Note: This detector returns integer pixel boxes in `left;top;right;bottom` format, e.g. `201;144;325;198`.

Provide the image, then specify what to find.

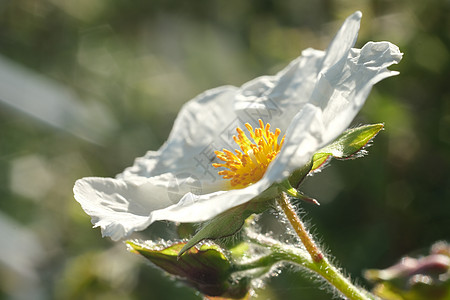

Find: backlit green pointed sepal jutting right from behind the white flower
311;124;384;171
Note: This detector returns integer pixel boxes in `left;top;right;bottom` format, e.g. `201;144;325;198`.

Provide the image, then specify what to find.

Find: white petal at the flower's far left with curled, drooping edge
73;169;230;240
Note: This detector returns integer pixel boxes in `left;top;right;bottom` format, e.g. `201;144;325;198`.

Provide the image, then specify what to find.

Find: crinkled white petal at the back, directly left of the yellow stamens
119;86;238;181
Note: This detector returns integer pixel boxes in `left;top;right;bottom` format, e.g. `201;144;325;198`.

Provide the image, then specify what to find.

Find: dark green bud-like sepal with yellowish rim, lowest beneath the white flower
127;241;249;299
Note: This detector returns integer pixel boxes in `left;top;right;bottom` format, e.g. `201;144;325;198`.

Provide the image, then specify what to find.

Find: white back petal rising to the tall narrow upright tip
235;12;361;132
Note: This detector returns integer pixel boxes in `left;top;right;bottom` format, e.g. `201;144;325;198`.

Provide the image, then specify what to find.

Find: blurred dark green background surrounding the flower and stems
0;0;450;299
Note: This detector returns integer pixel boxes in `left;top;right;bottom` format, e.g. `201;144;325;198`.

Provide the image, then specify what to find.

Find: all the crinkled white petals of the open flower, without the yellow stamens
74;12;402;240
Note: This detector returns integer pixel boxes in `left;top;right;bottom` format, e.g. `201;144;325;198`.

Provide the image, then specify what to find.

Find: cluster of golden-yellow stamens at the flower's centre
212;120;285;189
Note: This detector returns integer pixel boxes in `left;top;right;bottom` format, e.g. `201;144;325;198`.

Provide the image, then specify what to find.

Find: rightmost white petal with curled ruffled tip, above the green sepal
310;42;402;142
